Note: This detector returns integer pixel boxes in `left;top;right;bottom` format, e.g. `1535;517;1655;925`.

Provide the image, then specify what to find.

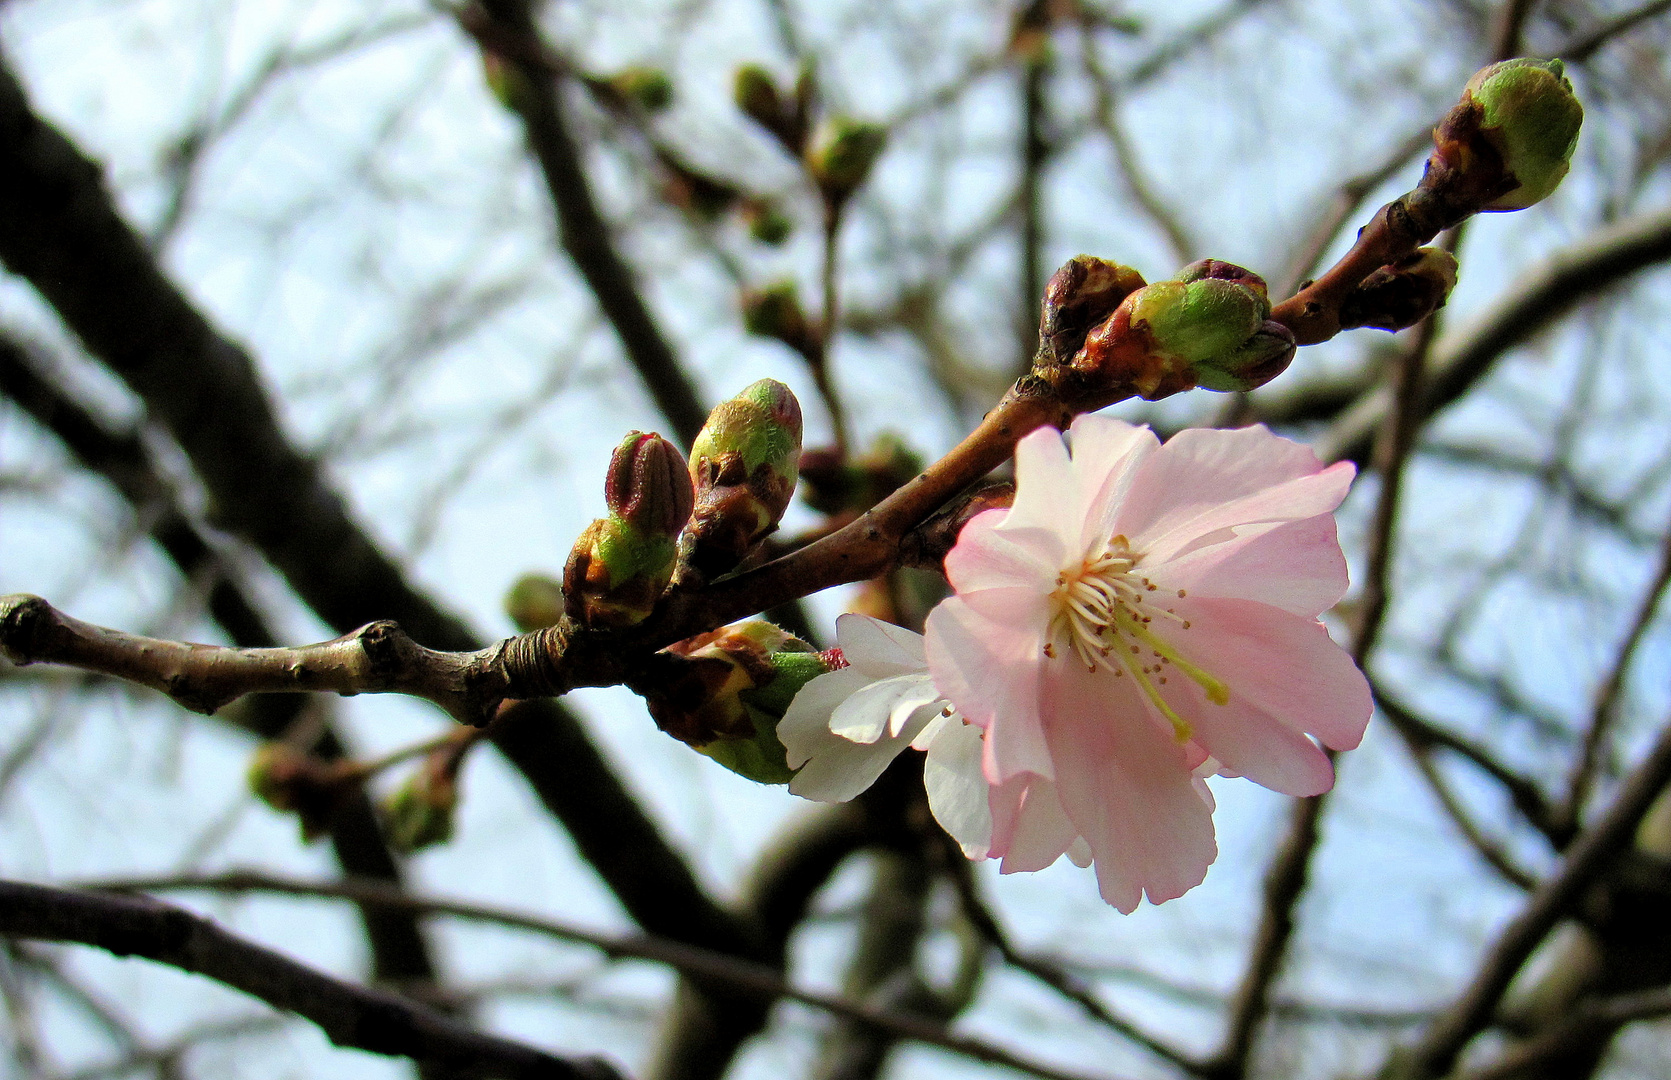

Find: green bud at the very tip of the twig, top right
1462;57;1584;211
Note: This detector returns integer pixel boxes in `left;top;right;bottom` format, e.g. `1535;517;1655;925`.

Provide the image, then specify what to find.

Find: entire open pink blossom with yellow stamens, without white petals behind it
926;416;1372;911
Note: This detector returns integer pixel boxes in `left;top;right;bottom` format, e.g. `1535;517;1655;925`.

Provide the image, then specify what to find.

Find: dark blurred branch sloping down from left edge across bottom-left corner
0;881;620;1080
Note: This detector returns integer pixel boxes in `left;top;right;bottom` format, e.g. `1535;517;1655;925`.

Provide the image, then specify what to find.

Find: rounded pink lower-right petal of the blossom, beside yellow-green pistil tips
1151;595;1374;752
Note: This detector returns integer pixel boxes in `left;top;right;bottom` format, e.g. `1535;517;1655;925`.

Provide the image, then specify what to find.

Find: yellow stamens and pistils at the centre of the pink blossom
1044;537;1230;742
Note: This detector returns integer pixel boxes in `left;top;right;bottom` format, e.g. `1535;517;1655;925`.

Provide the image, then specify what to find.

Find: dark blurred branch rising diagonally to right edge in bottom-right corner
1397;722;1671;1080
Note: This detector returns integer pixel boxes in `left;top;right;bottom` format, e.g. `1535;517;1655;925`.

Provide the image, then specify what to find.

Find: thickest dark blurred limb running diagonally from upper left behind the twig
0;55;749;950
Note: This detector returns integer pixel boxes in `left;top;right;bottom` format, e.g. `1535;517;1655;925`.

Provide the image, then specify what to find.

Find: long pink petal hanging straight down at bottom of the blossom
1044;664;1218;913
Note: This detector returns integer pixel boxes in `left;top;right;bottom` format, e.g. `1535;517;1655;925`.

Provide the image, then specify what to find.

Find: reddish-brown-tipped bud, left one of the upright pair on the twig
563;431;695;629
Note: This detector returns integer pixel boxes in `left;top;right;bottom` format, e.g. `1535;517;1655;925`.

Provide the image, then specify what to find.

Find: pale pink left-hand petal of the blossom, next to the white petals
924;597;1051;782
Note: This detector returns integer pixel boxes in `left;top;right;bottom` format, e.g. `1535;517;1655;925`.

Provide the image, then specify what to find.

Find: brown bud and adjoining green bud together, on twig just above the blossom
1034;256;1295;401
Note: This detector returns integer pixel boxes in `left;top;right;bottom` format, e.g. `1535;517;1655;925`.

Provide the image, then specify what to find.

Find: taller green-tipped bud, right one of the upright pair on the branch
680;380;800;577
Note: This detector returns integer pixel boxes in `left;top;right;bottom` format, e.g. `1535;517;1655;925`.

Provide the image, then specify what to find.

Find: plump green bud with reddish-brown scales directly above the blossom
1073;259;1295;401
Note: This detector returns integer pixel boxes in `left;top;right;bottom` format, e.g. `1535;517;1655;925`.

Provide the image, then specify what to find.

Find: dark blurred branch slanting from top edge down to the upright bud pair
458;0;709;446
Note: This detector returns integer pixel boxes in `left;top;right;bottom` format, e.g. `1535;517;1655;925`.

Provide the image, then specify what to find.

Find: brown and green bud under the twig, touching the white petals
648;620;836;784
